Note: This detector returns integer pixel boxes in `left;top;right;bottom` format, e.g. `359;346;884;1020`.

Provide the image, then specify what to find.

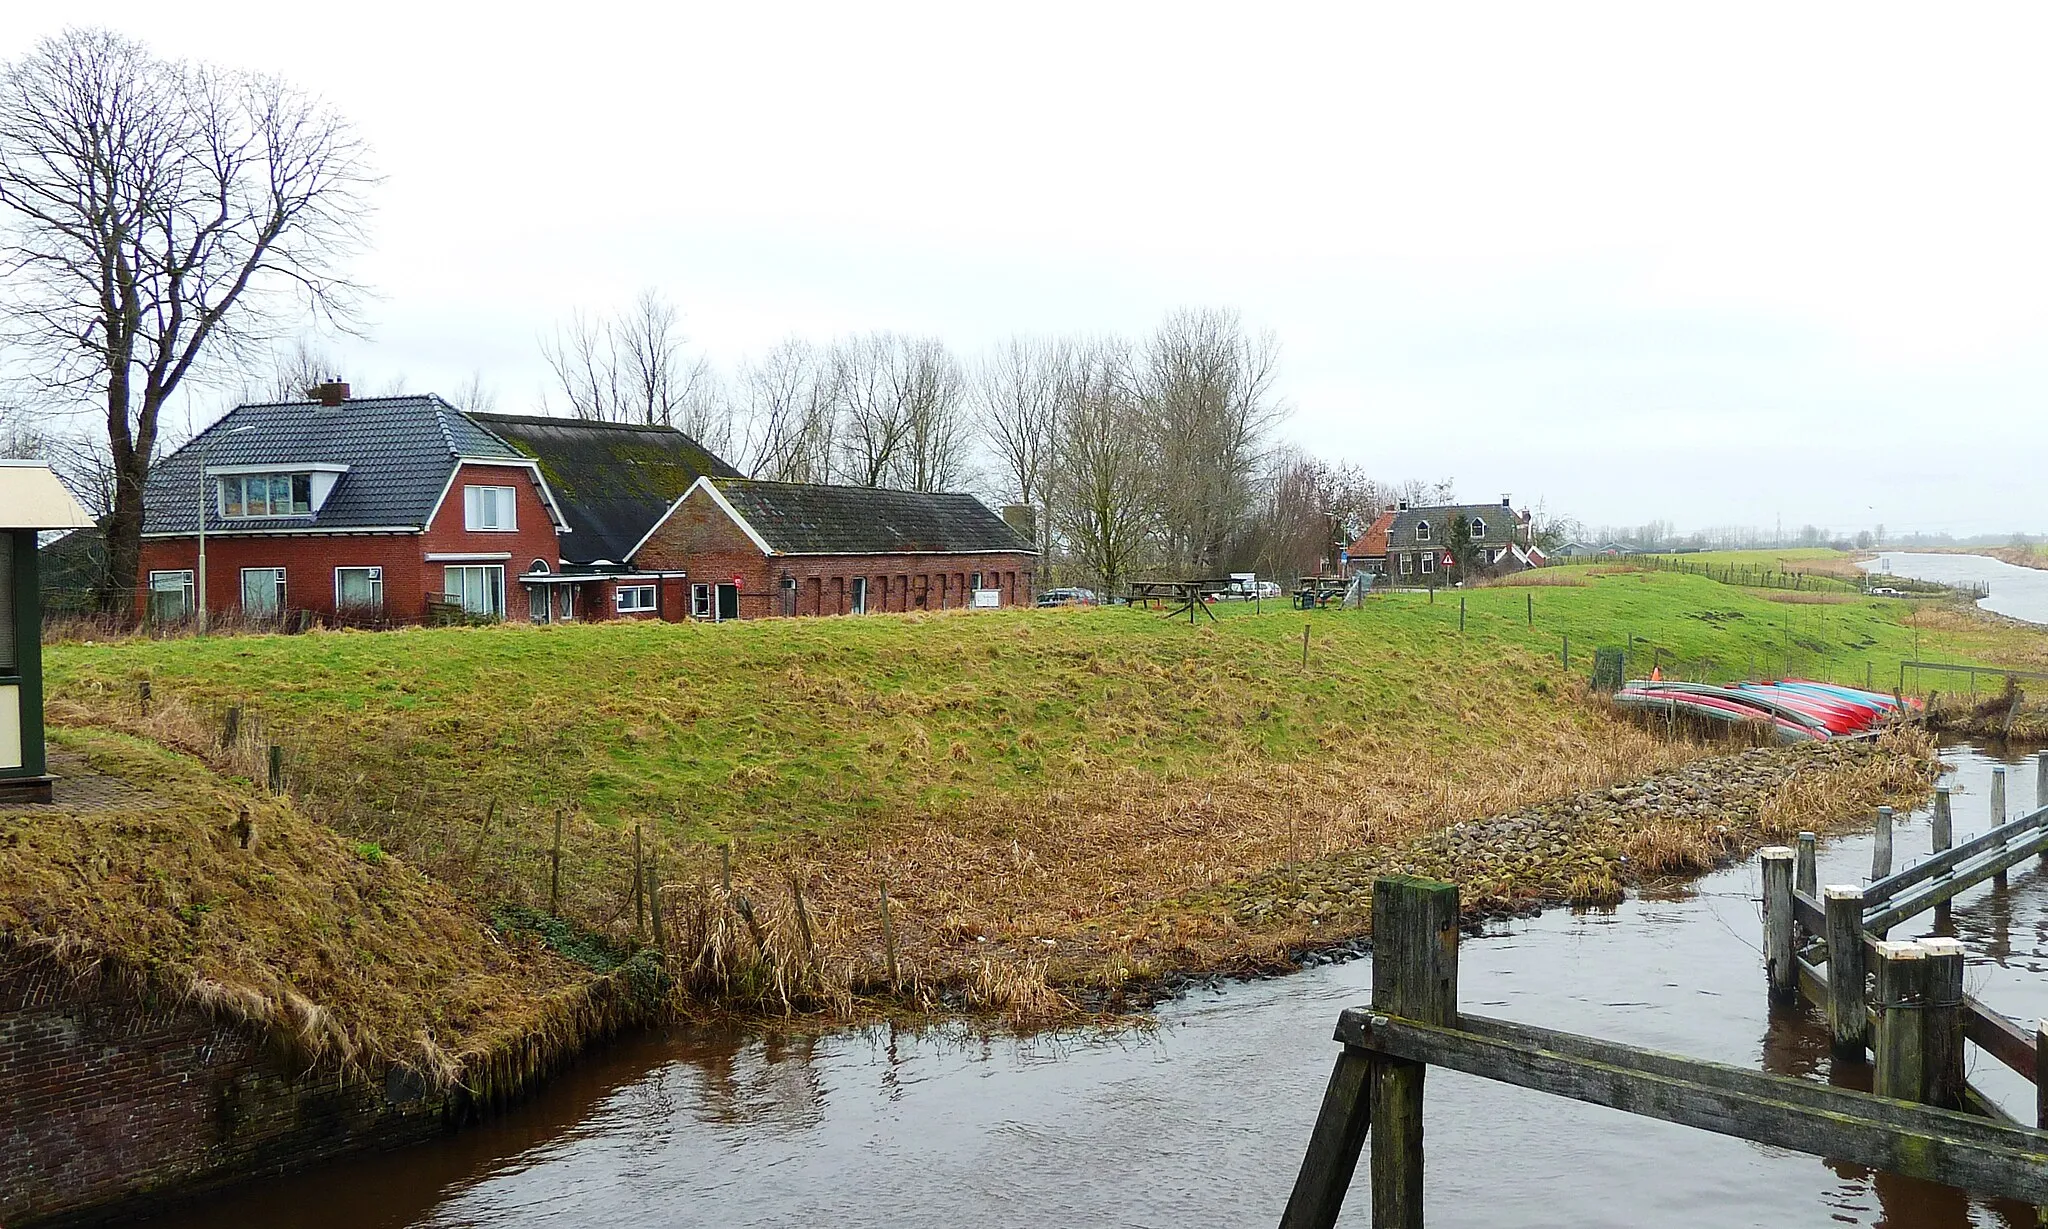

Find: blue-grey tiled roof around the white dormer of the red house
143;395;526;533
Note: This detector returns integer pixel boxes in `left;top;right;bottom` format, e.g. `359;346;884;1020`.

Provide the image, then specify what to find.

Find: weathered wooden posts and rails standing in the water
1280;848;2048;1229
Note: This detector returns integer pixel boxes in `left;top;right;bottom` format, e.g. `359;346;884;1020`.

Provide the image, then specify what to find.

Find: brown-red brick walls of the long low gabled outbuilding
633;492;1038;619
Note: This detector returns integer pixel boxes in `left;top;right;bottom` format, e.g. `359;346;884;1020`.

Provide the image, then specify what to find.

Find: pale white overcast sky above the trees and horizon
0;0;2048;533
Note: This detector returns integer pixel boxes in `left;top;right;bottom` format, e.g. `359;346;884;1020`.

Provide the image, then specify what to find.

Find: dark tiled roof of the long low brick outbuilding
713;477;1032;555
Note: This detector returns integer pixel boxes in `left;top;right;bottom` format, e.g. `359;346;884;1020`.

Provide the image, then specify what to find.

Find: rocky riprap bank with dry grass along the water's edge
1229;735;1939;938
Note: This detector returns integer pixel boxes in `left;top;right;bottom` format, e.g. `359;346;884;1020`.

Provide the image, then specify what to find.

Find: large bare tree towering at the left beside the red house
0;29;373;606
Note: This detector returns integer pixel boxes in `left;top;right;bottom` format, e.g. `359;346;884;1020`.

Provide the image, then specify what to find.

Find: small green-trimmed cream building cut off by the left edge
0;461;92;803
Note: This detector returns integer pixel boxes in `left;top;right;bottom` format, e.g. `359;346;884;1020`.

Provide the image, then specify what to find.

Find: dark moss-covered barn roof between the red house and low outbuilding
469;414;739;563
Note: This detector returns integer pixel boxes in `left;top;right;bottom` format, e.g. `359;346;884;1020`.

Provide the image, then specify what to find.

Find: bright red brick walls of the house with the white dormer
135;463;561;623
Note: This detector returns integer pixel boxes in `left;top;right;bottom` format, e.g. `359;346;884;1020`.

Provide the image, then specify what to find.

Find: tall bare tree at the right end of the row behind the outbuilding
1137;309;1284;571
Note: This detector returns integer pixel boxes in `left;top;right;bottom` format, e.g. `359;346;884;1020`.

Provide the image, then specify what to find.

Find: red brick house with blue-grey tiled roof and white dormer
137;383;567;623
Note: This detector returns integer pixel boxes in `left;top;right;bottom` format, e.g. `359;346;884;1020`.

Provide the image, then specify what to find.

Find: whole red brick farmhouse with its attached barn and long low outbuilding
137;383;1038;623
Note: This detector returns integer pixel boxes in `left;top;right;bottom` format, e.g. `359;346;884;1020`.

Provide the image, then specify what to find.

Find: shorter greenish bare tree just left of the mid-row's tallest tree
1049;340;1159;592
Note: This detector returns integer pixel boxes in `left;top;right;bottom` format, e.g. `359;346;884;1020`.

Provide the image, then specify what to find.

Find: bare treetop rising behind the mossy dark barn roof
541;291;729;436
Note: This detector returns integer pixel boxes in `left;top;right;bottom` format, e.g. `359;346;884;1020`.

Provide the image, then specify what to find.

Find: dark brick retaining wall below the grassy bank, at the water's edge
0;958;442;1229
